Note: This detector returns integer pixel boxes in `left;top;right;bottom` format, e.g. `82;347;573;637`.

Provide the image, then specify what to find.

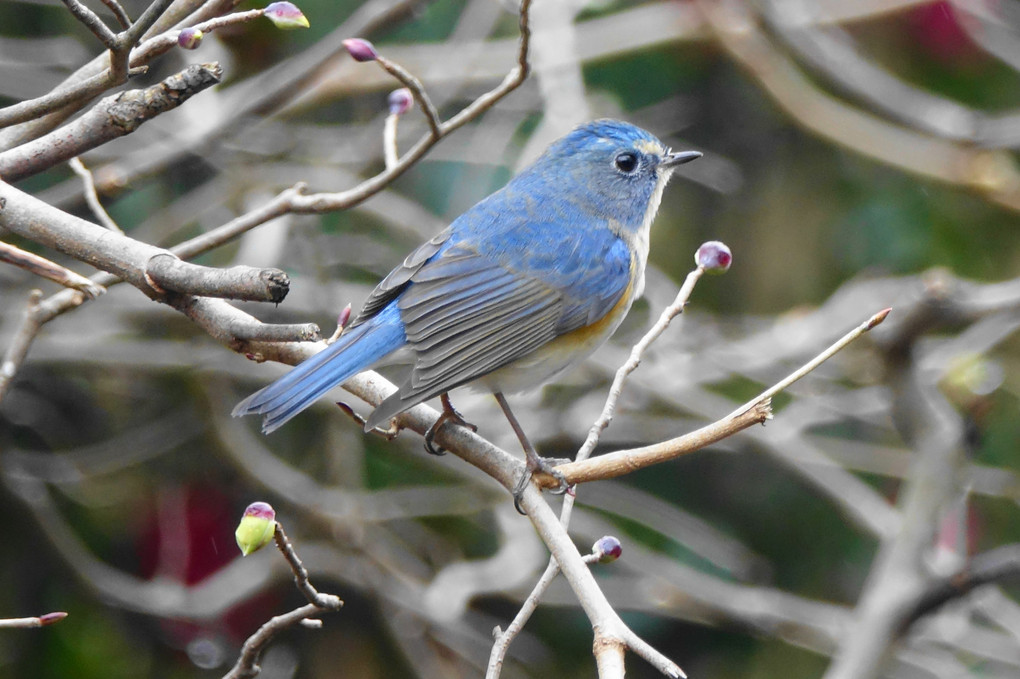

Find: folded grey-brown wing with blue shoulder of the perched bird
369;205;631;424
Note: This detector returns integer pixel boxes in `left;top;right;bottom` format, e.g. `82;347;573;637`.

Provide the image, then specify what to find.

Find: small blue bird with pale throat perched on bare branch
234;119;702;489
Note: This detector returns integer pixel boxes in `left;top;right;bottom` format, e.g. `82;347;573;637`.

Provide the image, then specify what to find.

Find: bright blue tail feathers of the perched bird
231;308;407;433
